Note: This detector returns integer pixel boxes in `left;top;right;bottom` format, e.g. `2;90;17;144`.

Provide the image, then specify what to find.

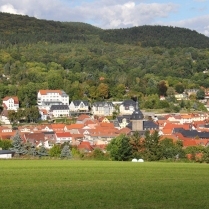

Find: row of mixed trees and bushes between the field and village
0;131;209;163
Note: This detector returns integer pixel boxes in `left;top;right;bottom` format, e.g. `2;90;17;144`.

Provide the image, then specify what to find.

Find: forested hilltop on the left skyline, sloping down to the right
0;12;101;44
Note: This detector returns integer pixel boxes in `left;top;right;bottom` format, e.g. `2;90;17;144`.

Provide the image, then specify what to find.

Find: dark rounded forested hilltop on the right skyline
101;26;209;48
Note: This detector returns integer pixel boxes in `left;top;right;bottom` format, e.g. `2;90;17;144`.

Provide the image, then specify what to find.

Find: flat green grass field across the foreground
0;160;209;209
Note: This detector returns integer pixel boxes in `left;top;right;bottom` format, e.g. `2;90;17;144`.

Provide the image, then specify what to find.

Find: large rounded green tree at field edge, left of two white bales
107;135;132;161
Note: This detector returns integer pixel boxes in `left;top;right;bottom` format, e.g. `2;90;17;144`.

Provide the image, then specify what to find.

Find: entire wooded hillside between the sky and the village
0;13;209;111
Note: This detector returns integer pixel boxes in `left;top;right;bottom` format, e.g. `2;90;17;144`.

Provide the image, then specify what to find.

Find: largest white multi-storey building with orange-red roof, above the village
37;90;69;110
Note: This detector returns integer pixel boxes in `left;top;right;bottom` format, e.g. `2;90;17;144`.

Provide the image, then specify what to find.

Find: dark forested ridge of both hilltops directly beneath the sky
0;13;209;48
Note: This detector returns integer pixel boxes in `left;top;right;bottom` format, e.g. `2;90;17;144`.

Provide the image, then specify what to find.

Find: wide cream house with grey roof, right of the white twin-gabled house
92;102;115;116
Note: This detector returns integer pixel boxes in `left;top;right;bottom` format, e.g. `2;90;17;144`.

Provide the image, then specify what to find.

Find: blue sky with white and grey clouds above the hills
0;0;209;36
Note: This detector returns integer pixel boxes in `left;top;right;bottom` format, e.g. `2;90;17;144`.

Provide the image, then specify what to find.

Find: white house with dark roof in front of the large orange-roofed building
49;105;70;118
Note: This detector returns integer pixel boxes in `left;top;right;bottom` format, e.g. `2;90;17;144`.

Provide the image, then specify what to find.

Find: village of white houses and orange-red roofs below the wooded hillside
0;90;209;152
